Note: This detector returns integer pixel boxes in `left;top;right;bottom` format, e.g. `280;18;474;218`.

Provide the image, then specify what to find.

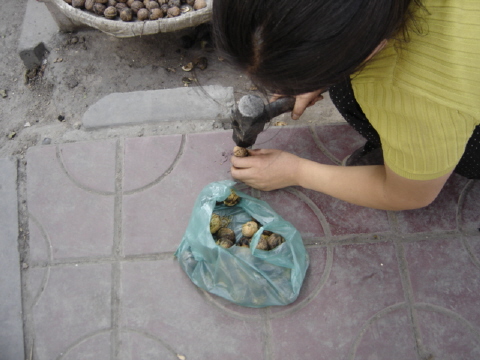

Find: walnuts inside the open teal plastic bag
210;190;285;250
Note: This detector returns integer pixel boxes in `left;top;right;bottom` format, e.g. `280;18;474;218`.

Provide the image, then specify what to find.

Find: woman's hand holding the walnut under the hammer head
231;149;302;191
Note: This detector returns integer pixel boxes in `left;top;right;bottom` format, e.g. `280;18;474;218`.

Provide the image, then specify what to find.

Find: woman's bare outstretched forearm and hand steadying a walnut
232;149;450;210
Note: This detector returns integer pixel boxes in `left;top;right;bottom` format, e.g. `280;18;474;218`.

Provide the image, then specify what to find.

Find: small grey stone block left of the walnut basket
18;0;58;69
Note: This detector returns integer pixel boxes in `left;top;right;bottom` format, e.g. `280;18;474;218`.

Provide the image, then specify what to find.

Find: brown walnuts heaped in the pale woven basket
64;0;207;21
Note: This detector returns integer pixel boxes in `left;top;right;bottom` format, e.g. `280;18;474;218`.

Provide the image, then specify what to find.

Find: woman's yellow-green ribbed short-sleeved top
352;0;480;180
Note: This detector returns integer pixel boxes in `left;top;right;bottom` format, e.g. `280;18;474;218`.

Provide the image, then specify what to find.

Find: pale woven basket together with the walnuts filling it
44;0;212;37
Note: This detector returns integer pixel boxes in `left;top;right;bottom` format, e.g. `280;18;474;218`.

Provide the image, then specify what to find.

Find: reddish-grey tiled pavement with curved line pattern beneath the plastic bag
23;124;480;360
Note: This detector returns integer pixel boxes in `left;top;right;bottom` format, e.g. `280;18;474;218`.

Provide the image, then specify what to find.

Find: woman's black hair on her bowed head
212;0;421;95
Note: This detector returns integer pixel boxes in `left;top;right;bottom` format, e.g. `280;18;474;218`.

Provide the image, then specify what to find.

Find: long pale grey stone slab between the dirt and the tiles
82;85;235;130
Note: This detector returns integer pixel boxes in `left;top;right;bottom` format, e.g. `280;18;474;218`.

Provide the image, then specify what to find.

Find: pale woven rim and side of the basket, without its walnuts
43;0;212;37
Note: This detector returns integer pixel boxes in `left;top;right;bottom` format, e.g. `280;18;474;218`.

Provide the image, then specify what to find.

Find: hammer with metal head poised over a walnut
232;95;295;148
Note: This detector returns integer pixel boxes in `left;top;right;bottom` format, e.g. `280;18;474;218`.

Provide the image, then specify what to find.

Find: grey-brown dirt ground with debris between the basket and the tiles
0;0;264;158
